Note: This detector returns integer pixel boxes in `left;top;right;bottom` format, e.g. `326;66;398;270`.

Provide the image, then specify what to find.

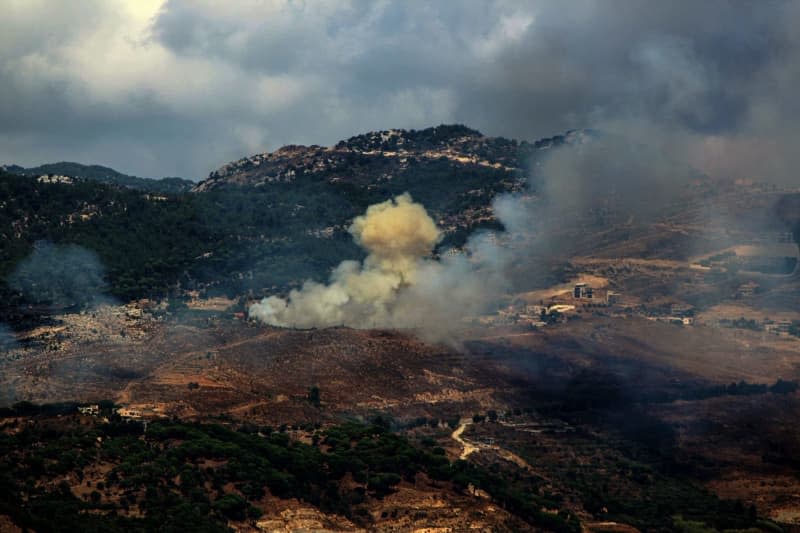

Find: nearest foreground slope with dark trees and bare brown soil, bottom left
0;414;556;533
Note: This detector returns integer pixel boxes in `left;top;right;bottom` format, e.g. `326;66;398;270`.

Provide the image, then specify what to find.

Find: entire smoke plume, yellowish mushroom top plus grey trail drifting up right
250;119;800;345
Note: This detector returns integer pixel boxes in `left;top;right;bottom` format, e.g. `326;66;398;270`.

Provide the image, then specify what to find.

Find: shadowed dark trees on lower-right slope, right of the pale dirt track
500;408;774;532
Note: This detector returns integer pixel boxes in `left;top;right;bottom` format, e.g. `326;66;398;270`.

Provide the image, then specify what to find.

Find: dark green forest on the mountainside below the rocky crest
0;139;514;309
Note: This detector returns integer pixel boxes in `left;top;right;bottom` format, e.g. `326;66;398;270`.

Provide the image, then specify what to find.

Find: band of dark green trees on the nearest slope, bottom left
0;412;580;532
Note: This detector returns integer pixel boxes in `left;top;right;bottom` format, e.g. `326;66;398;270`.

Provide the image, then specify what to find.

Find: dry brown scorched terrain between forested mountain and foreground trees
0;181;800;531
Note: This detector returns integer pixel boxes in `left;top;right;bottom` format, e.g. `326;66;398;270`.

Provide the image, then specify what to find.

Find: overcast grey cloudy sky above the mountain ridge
0;0;800;182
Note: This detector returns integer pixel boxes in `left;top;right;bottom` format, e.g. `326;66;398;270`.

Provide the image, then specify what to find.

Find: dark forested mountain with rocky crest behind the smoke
0;126;580;308
